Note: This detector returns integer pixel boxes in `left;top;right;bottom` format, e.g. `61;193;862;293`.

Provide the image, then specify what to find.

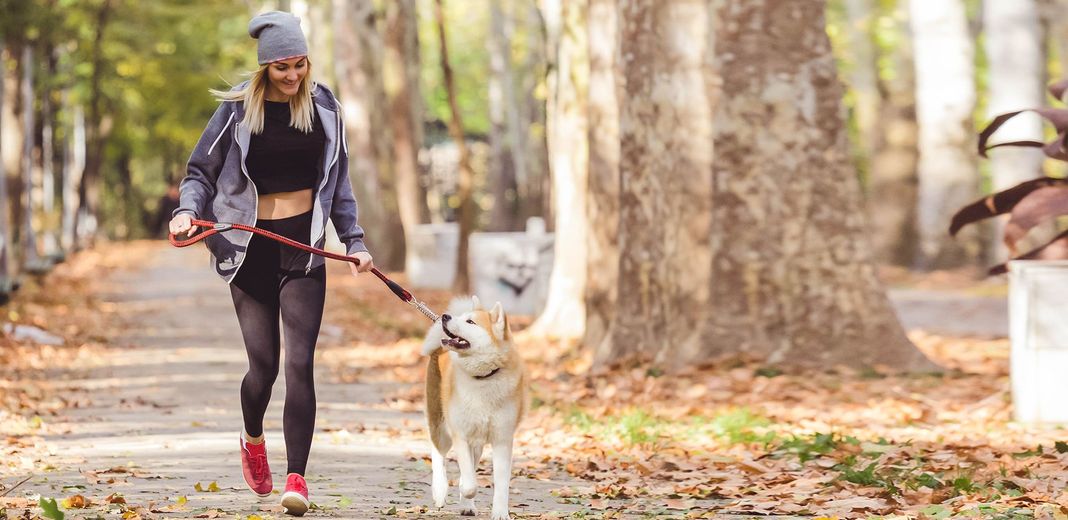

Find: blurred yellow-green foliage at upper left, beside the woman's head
0;0;255;237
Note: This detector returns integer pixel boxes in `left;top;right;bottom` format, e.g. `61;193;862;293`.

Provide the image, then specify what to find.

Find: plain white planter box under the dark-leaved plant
1008;261;1068;423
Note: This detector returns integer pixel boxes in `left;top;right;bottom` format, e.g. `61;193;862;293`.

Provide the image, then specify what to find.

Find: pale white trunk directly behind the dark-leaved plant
983;0;1046;264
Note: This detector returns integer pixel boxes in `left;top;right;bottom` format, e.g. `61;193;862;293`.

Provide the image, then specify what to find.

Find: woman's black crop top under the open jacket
245;99;327;195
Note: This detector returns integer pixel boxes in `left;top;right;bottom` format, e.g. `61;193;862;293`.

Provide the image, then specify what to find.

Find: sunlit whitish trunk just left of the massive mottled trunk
530;0;590;340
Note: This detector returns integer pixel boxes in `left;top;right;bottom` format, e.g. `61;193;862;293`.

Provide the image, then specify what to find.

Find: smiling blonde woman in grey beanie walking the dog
170;11;374;516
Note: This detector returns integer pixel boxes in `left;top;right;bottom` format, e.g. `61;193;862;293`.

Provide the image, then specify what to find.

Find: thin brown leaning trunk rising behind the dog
434;0;475;294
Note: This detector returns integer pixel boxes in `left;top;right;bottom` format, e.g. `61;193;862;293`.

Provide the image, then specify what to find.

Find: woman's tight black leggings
230;211;326;475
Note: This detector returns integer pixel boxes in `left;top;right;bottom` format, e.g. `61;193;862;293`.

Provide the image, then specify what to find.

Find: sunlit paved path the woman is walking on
18;248;579;519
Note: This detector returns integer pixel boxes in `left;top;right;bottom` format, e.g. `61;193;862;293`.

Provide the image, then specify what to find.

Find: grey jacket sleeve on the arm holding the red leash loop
171;103;234;222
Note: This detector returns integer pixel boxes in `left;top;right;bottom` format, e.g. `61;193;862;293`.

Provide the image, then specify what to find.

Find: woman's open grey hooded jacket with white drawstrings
172;81;367;284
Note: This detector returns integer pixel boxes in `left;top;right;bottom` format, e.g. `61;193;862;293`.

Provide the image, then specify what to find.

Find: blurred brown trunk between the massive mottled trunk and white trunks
867;2;920;266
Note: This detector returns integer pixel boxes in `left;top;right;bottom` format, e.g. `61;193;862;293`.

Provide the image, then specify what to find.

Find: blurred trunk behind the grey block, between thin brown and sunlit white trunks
487;0;527;232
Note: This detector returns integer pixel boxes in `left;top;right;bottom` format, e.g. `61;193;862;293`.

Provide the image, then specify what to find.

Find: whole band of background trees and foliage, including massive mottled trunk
0;0;1055;367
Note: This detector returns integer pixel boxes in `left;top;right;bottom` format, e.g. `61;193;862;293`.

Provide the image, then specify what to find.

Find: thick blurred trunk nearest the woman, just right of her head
333;0;405;269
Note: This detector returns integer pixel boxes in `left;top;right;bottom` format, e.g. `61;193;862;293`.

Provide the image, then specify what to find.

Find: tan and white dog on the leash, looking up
423;298;527;520
